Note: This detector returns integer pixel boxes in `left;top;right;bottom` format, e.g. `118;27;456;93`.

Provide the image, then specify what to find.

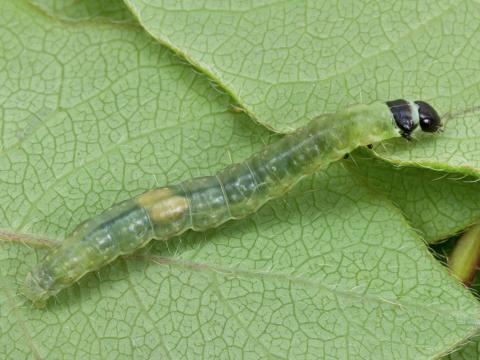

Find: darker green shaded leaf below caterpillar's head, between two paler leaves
348;149;480;242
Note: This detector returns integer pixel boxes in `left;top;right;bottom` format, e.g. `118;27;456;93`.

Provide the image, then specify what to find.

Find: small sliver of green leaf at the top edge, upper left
29;0;135;23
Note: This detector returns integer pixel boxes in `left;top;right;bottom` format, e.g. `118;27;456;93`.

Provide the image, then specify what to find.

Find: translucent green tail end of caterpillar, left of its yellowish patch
23;200;153;307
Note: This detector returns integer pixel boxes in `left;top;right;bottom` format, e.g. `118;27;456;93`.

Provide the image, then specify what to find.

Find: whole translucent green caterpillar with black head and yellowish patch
24;100;442;306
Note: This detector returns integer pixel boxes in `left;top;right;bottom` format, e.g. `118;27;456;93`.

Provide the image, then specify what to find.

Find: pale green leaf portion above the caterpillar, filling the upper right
125;0;480;131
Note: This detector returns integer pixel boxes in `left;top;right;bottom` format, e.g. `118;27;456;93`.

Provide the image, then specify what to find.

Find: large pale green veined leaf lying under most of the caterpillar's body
0;1;480;359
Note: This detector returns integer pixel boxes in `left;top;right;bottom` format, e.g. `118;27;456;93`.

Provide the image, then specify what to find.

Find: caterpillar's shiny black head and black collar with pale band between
387;99;442;140
